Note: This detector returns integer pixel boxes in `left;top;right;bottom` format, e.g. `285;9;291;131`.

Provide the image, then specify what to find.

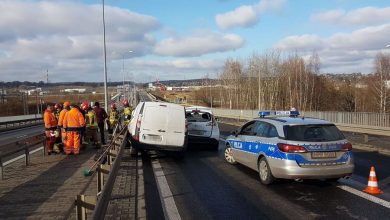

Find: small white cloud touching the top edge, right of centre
215;0;286;30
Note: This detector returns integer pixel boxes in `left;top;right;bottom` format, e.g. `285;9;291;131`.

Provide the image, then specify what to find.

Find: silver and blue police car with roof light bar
225;111;354;185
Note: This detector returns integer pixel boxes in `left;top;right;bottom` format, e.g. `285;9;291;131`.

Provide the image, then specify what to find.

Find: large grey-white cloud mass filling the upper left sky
0;0;160;82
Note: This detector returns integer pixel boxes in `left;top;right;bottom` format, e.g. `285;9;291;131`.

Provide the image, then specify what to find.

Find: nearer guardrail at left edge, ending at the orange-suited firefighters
0;134;46;180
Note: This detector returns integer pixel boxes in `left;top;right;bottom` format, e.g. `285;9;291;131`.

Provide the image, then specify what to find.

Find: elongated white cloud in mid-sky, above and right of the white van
154;31;245;57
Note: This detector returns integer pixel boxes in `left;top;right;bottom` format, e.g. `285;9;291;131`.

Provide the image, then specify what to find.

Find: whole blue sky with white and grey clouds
0;0;390;82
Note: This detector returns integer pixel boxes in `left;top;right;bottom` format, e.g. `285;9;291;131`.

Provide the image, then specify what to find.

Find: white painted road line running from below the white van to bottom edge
152;160;181;220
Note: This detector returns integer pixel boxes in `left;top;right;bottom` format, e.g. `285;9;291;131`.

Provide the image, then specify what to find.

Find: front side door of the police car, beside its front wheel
233;121;256;164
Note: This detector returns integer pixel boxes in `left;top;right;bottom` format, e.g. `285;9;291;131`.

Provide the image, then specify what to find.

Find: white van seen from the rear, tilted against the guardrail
128;102;187;152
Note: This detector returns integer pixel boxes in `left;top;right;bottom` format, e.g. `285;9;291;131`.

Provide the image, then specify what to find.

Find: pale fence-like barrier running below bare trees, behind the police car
213;108;390;136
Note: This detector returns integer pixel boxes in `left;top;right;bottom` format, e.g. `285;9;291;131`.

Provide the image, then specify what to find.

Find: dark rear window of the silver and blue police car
284;124;345;142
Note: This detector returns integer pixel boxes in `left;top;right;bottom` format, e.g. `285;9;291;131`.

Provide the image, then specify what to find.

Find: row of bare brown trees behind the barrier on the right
195;51;390;113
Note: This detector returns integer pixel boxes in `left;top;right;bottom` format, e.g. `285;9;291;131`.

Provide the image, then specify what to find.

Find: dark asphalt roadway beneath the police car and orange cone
144;124;390;219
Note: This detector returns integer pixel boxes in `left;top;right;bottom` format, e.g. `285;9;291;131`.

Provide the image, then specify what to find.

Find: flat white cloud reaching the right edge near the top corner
311;7;390;26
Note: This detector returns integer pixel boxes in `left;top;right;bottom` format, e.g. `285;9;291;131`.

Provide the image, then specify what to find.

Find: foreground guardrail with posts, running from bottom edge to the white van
75;126;127;220
